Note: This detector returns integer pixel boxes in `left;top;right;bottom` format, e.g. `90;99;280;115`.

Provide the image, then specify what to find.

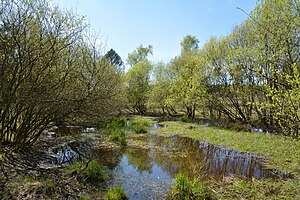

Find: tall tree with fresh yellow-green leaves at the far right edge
251;0;300;137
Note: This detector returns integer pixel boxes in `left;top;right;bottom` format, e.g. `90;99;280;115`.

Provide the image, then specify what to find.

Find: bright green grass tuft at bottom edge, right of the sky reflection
168;173;213;200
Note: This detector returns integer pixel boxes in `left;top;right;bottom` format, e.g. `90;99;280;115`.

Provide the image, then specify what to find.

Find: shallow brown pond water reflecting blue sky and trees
50;124;290;199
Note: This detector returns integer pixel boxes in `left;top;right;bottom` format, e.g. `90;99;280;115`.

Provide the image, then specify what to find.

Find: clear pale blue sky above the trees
53;0;256;62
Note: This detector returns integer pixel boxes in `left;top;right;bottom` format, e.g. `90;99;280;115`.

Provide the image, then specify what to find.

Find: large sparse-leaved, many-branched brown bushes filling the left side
0;0;124;148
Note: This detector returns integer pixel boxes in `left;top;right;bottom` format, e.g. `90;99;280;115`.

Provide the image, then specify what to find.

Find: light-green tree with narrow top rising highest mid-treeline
169;35;206;118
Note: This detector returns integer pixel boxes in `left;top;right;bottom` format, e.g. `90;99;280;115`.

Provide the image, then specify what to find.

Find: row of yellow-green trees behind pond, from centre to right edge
127;0;300;138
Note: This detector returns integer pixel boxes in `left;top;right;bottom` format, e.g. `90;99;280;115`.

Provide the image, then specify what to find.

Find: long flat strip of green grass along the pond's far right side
157;121;300;173
